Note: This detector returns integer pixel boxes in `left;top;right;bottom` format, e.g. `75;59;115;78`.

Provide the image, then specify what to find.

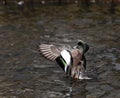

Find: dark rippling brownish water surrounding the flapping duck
0;5;120;98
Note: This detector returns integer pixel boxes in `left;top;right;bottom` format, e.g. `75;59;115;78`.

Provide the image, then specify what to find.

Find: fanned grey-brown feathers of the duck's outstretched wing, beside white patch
39;44;71;61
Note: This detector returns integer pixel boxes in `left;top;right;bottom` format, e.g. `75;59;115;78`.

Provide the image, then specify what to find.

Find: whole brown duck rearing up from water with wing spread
39;40;91;80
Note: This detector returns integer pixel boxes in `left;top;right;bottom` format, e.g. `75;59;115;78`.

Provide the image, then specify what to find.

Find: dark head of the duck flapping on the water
76;40;89;54
